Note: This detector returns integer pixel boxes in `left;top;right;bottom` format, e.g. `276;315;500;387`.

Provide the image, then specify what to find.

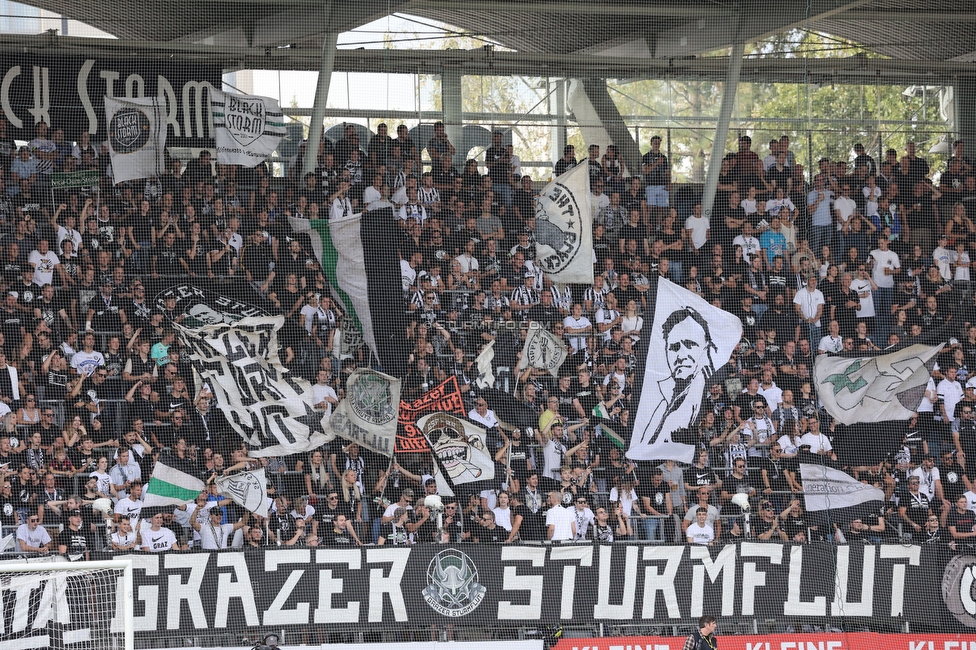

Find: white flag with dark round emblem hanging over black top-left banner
105;96;167;185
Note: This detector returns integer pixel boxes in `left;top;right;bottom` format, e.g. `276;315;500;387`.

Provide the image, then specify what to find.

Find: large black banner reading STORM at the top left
0;56;222;147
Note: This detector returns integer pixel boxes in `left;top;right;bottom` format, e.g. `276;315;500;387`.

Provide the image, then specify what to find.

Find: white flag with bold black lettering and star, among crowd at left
175;314;333;457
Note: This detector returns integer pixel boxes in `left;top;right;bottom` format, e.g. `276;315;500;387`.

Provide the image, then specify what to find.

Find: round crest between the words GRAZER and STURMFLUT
423;549;488;618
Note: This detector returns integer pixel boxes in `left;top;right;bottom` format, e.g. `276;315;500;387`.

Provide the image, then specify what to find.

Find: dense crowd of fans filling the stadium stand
0;119;976;557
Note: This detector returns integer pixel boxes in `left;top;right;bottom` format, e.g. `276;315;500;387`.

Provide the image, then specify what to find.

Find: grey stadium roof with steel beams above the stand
7;0;976;82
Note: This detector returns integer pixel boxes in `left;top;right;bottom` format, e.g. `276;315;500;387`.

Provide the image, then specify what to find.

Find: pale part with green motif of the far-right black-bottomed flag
813;344;945;424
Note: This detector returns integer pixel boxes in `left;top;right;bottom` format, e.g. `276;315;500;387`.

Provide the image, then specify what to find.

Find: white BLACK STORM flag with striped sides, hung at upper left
210;90;285;167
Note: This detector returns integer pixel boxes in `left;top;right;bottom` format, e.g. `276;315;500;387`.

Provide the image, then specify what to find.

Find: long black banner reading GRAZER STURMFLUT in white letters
0;542;976;650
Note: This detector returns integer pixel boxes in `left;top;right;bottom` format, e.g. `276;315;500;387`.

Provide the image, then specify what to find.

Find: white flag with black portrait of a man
627;278;742;463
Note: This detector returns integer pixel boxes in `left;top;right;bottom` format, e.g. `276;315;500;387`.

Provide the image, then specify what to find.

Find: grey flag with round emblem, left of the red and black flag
329;368;401;456
